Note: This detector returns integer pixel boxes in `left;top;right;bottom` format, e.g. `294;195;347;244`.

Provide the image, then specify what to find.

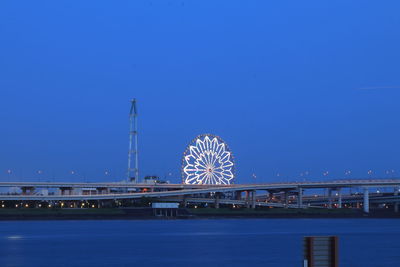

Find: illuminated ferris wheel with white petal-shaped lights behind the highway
182;134;235;185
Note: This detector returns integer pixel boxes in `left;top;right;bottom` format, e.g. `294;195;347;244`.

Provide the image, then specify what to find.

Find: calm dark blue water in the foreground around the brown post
0;219;400;267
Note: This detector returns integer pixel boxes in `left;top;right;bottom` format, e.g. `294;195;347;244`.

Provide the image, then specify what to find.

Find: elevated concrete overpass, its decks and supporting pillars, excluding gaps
0;179;400;212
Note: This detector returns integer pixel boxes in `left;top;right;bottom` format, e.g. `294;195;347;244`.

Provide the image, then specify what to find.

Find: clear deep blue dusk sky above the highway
0;0;400;183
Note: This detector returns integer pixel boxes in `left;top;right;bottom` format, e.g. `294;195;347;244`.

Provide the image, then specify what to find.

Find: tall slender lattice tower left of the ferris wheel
127;99;139;183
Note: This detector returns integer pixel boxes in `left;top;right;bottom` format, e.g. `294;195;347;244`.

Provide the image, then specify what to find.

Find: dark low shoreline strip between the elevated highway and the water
0;208;400;221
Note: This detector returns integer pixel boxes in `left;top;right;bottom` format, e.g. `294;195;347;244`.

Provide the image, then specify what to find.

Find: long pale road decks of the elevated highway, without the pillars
0;179;400;201
